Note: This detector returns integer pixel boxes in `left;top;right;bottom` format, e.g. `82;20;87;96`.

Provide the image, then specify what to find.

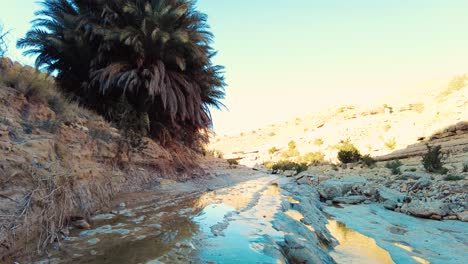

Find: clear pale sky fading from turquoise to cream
0;0;468;134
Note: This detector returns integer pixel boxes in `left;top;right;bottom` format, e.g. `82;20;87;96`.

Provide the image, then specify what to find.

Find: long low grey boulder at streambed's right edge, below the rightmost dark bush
401;200;450;218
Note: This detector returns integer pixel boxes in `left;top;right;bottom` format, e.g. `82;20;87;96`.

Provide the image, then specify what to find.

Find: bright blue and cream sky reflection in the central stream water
194;185;285;263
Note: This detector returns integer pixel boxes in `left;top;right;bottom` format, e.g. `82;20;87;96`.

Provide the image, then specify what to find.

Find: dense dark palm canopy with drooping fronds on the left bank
18;0;228;146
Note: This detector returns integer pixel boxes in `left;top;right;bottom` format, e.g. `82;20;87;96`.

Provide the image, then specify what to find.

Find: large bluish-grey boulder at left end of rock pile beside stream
318;176;367;200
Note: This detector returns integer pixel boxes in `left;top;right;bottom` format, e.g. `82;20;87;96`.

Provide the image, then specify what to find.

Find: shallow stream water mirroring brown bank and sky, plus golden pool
38;176;462;264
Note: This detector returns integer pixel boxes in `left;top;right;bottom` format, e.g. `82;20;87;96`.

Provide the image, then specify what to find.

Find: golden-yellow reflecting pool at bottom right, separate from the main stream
327;220;394;264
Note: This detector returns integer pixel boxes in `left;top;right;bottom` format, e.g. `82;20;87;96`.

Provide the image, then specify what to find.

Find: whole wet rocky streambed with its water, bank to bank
33;170;468;263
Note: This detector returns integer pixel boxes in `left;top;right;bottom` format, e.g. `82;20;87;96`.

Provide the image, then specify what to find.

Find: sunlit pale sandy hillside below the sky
210;75;468;165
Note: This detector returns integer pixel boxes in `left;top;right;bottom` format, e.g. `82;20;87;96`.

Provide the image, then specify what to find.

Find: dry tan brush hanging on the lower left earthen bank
0;163;114;261
